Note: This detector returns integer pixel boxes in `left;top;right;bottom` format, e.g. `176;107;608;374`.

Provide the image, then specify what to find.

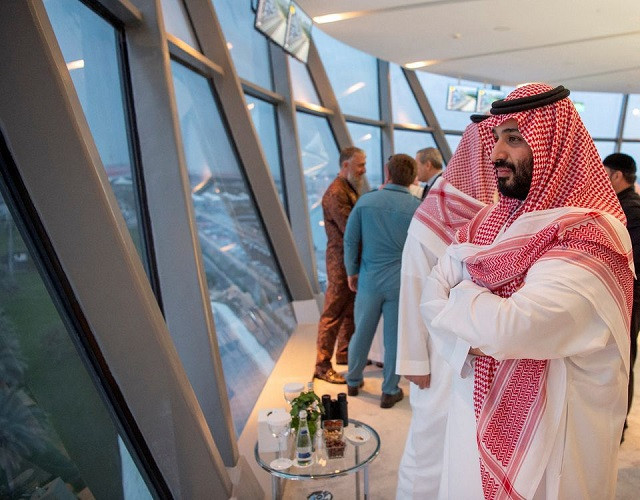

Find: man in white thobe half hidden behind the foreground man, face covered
396;115;496;500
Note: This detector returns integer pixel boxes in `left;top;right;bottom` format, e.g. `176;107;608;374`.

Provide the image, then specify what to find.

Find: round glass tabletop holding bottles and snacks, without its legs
254;418;380;479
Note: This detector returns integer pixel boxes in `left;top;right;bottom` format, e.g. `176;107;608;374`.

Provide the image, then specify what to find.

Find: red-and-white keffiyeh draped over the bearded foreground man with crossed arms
460;84;632;499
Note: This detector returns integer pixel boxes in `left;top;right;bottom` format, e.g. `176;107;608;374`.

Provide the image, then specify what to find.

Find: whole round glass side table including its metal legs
254;418;380;500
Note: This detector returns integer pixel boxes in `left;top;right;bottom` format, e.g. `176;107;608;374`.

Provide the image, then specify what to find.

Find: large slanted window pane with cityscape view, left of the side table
171;62;295;434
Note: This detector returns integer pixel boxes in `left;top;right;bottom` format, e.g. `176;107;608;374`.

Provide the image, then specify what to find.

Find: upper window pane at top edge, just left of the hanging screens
212;0;273;90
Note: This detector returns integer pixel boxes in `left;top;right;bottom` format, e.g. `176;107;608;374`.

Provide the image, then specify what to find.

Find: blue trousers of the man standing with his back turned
346;286;400;394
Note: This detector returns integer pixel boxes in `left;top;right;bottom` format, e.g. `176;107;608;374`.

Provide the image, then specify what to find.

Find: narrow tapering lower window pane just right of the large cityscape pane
245;94;286;207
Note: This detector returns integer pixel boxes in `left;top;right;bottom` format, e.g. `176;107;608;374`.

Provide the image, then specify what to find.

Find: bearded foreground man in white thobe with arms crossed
421;84;633;499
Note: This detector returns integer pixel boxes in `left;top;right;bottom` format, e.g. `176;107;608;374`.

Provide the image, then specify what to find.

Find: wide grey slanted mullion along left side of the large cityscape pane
125;0;238;465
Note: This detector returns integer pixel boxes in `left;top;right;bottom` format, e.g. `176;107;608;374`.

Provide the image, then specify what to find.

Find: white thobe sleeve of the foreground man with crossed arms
421;255;611;368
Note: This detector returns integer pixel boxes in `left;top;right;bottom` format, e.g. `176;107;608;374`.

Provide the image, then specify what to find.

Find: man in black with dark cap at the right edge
602;153;640;439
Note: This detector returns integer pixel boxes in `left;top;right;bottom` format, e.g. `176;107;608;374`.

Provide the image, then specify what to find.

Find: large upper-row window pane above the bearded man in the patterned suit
313;29;380;120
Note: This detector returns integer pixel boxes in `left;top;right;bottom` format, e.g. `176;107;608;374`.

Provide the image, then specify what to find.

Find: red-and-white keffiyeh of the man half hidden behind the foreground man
414;123;496;245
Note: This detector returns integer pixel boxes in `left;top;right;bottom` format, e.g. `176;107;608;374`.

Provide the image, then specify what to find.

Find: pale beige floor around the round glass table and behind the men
244;325;640;500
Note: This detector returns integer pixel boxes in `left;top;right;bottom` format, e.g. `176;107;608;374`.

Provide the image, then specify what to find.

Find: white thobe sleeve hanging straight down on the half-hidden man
396;231;438;375
